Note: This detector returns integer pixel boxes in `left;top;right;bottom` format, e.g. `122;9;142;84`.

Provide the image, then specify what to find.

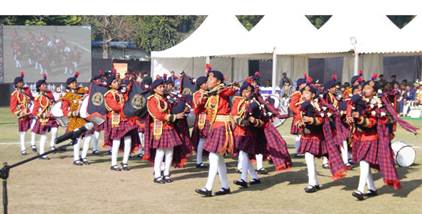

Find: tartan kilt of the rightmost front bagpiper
356;140;380;167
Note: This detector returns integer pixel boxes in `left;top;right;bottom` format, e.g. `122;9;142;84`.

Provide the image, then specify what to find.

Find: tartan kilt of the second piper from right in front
299;135;328;158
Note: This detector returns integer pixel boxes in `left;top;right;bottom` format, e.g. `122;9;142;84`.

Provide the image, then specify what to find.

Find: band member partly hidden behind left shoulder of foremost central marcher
191;76;210;168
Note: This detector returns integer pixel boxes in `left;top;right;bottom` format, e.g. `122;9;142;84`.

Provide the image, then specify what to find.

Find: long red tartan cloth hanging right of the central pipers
263;121;292;171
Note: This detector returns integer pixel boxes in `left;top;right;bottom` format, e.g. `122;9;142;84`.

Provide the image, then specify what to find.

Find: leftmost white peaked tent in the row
151;15;248;80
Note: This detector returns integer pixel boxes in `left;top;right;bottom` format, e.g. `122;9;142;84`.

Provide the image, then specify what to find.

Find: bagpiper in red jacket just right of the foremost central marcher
231;81;264;188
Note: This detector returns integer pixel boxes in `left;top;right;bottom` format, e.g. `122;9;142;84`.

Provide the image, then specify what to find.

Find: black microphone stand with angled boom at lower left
0;138;78;214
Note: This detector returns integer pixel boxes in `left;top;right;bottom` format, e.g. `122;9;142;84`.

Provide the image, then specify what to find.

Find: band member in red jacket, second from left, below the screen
32;74;53;159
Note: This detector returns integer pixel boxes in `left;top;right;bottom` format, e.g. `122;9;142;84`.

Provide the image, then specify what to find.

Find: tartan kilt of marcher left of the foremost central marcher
150;127;183;149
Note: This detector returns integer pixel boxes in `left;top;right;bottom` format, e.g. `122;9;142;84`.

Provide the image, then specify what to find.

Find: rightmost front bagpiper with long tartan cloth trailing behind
349;78;417;200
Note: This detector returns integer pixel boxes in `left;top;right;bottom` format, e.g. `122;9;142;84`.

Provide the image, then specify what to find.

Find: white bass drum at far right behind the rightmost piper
391;141;416;167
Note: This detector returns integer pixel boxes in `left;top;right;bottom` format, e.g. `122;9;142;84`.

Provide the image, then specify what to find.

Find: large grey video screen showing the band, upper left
3;26;91;82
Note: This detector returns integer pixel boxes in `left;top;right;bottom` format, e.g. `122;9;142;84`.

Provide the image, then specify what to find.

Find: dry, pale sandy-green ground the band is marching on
0;108;422;214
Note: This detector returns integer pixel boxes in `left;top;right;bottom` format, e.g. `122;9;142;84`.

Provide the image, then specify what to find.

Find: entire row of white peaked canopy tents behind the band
151;12;422;88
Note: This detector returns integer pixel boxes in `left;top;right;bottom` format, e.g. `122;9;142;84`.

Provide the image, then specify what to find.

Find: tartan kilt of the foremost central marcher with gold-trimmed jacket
204;125;233;153
